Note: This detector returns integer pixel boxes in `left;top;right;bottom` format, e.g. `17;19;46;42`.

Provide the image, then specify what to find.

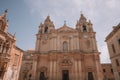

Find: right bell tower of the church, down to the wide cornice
76;14;98;52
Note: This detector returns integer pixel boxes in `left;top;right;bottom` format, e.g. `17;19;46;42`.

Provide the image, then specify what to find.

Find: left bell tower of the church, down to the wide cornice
36;15;55;51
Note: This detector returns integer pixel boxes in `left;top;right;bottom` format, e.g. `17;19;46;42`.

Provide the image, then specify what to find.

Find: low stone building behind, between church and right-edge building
101;63;115;80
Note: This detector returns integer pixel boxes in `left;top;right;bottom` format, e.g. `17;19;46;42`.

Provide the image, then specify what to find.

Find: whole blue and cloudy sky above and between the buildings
0;0;120;63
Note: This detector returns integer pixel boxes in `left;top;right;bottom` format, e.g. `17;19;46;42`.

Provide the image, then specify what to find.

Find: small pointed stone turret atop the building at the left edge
0;10;8;32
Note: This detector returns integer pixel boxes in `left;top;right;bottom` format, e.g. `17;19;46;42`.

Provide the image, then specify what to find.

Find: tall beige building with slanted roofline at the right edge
105;23;120;80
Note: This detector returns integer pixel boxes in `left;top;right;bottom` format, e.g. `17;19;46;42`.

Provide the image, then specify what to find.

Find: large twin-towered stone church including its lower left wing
19;14;103;80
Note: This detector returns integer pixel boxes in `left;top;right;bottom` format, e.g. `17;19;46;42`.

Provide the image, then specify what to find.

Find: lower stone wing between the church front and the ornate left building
18;50;36;80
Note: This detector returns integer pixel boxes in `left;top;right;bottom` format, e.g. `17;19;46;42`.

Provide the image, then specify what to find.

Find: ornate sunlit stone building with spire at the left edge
0;10;23;80
